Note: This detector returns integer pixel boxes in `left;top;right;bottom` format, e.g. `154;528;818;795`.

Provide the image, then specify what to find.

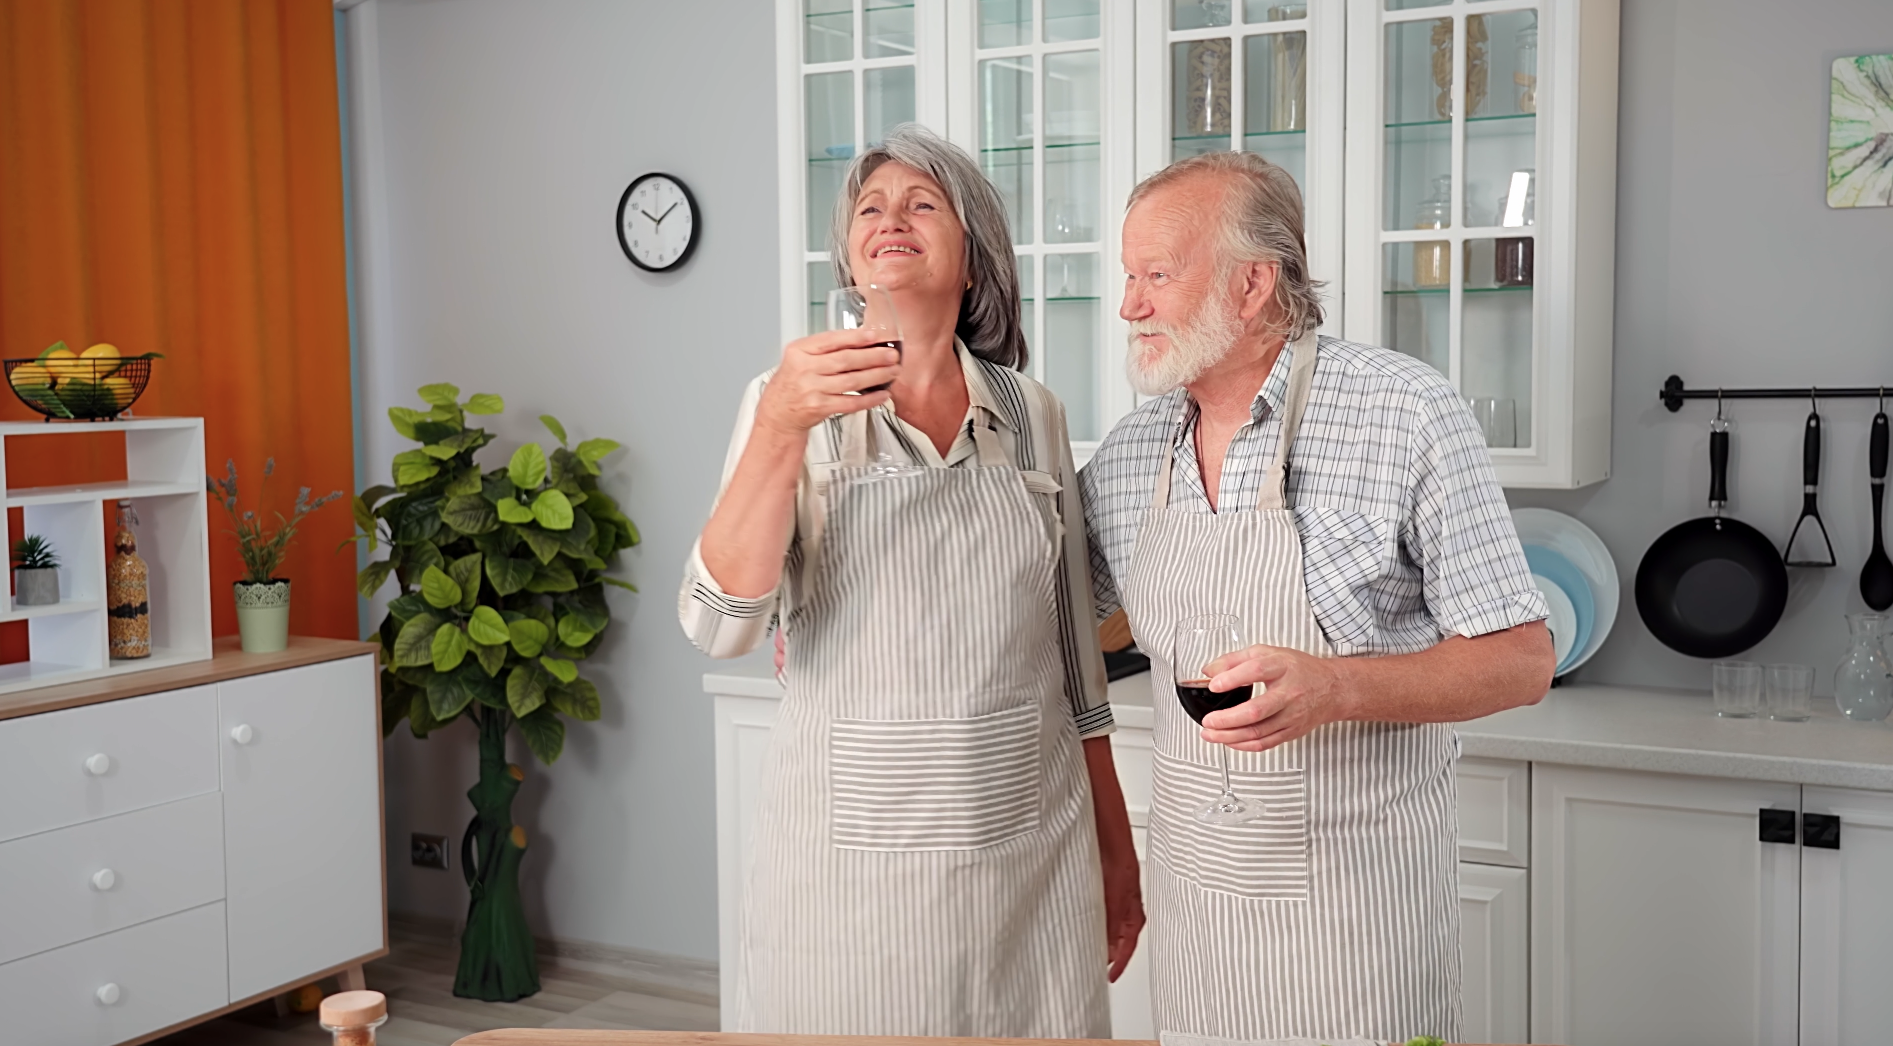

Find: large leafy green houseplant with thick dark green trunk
354;384;638;1001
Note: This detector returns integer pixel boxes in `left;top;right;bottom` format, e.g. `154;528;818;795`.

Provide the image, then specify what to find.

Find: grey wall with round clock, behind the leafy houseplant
346;0;778;959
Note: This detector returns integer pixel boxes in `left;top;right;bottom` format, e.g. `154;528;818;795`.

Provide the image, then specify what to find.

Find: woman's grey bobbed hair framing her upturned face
829;123;1026;371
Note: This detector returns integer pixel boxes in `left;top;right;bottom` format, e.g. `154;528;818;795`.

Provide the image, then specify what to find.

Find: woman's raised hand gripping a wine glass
755;327;901;439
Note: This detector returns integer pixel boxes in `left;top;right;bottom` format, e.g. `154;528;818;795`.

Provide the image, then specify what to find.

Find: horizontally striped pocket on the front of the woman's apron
829;702;1043;851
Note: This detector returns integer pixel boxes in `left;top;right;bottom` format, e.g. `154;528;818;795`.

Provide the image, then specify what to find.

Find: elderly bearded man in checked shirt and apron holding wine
1083;153;1552;1040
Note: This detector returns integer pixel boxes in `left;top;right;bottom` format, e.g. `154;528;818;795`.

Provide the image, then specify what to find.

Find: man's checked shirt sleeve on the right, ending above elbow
1401;385;1548;636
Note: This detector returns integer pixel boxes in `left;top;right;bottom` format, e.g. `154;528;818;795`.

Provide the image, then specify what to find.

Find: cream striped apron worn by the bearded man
1123;333;1460;1042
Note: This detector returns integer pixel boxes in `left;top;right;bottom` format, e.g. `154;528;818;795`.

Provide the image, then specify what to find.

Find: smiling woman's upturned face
848;161;965;299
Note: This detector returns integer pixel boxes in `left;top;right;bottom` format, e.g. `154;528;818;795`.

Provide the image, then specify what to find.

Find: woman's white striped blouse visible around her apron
678;342;1113;738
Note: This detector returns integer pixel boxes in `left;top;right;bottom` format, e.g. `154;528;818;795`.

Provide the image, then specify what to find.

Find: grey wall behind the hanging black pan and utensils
1511;0;1893;694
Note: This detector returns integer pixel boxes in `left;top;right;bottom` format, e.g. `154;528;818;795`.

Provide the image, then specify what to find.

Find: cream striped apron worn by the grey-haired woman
734;414;1109;1038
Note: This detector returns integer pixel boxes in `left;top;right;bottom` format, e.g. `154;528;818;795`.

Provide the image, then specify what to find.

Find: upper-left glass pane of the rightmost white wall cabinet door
1382;19;1452;229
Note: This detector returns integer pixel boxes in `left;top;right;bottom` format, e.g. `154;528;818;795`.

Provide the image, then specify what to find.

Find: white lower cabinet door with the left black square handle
1531;764;1800;1046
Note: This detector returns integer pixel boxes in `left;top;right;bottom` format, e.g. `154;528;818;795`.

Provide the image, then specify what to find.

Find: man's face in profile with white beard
1117;178;1244;395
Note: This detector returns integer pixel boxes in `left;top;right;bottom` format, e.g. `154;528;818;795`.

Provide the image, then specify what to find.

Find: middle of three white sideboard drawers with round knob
0;793;223;963
